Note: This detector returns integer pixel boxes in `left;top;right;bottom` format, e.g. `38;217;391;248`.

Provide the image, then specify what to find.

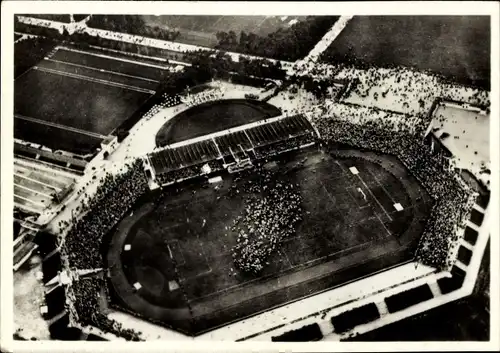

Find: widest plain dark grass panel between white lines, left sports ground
14;70;150;135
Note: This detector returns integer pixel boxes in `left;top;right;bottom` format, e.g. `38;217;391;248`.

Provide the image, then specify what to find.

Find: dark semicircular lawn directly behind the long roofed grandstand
156;99;281;146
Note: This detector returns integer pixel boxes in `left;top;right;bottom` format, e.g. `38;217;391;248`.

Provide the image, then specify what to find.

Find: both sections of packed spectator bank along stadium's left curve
61;160;147;340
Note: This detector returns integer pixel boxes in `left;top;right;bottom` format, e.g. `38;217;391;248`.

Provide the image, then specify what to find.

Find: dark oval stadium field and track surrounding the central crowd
107;148;432;334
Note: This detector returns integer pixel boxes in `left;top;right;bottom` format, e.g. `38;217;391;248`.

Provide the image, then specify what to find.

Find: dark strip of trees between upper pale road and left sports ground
16;15;331;98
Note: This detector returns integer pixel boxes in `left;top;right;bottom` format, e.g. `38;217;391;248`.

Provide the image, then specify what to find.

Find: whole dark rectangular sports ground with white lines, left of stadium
14;47;174;155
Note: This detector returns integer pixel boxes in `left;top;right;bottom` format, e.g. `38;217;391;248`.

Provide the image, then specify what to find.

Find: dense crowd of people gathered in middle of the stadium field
230;170;302;274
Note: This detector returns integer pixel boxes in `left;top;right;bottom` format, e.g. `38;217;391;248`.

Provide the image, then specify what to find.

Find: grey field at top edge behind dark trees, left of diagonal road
142;15;305;48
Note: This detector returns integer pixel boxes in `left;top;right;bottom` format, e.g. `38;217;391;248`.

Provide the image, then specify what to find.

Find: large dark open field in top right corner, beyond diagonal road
323;16;490;86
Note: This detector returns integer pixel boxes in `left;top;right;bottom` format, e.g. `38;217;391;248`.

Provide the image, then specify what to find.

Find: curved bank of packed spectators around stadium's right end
313;116;473;269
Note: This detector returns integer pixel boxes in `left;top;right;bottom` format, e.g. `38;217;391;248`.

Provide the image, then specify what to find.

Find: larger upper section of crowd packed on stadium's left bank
62;160;148;269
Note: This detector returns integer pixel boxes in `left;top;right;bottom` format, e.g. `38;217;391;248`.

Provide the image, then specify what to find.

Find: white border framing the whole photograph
0;1;500;352
